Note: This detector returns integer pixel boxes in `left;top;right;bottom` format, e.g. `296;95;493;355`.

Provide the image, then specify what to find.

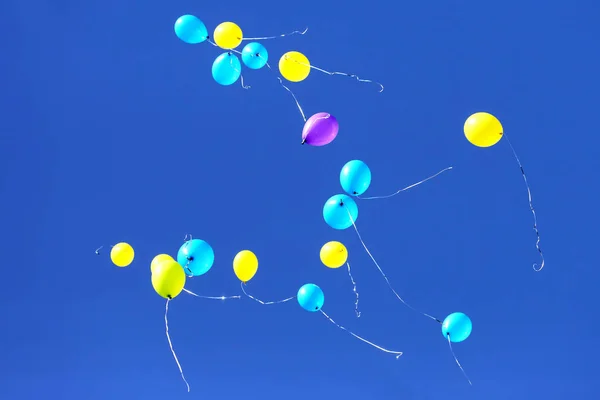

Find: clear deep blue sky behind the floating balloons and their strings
0;0;600;400
